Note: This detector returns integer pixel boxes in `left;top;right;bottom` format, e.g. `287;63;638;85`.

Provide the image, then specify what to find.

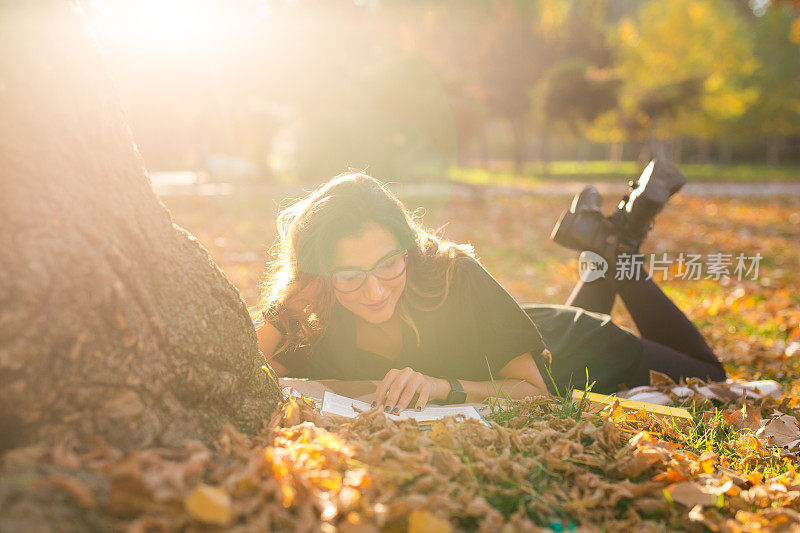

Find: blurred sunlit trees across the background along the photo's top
84;0;800;183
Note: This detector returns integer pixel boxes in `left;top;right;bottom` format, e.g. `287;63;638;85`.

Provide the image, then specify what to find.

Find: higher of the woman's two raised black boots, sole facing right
608;160;686;248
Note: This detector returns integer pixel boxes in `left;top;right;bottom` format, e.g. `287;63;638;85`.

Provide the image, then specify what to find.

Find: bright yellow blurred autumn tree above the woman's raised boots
614;0;758;163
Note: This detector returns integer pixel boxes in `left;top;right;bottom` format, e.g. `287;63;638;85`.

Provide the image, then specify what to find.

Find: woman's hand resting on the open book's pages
372;367;450;414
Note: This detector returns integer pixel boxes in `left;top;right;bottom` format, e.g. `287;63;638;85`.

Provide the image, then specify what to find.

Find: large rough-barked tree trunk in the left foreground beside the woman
0;1;280;450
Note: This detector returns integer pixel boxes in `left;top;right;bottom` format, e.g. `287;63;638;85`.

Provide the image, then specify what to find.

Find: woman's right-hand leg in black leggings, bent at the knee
616;272;725;381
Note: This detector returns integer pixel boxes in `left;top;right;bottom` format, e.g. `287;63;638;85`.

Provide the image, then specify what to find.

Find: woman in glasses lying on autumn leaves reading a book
257;168;725;413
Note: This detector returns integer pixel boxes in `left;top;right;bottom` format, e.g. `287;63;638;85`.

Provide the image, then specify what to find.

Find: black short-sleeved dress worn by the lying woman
275;257;641;392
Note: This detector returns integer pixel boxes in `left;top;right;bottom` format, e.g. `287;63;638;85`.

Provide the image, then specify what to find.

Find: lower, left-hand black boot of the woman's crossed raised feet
550;185;625;265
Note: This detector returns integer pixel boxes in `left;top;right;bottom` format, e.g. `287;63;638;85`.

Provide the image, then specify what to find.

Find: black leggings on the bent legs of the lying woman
566;272;725;386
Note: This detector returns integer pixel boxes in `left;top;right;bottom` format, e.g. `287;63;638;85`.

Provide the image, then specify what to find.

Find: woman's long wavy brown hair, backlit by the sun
259;173;473;355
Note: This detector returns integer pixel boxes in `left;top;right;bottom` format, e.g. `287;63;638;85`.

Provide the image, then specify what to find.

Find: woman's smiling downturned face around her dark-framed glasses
333;222;406;324
